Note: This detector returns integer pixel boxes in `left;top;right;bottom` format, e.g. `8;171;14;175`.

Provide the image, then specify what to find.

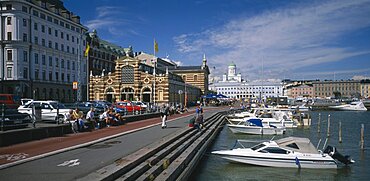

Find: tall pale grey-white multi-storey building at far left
0;0;88;102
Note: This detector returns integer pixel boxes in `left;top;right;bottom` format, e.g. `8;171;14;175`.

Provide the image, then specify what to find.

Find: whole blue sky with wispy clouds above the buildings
64;0;370;80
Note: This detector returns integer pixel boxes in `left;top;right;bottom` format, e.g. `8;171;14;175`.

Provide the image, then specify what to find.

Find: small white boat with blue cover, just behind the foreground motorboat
227;118;285;135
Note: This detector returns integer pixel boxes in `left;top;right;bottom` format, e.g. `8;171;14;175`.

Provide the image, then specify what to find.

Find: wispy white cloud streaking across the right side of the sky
173;0;370;79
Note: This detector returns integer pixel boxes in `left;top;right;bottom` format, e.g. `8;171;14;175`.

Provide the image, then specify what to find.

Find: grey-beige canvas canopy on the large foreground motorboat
275;137;319;154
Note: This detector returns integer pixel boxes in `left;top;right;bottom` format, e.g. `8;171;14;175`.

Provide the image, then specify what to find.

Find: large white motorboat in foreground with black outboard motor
212;137;354;168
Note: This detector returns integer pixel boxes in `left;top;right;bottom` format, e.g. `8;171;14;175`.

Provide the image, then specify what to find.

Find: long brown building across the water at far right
312;80;361;98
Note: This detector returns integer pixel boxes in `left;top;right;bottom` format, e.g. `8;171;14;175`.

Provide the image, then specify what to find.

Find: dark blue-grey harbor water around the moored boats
190;111;370;181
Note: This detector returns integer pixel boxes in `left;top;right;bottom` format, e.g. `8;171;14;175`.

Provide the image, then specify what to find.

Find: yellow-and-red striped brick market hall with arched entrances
89;53;207;104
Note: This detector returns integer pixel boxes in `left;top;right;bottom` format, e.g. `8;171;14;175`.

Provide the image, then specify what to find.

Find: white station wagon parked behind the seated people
18;101;69;121
